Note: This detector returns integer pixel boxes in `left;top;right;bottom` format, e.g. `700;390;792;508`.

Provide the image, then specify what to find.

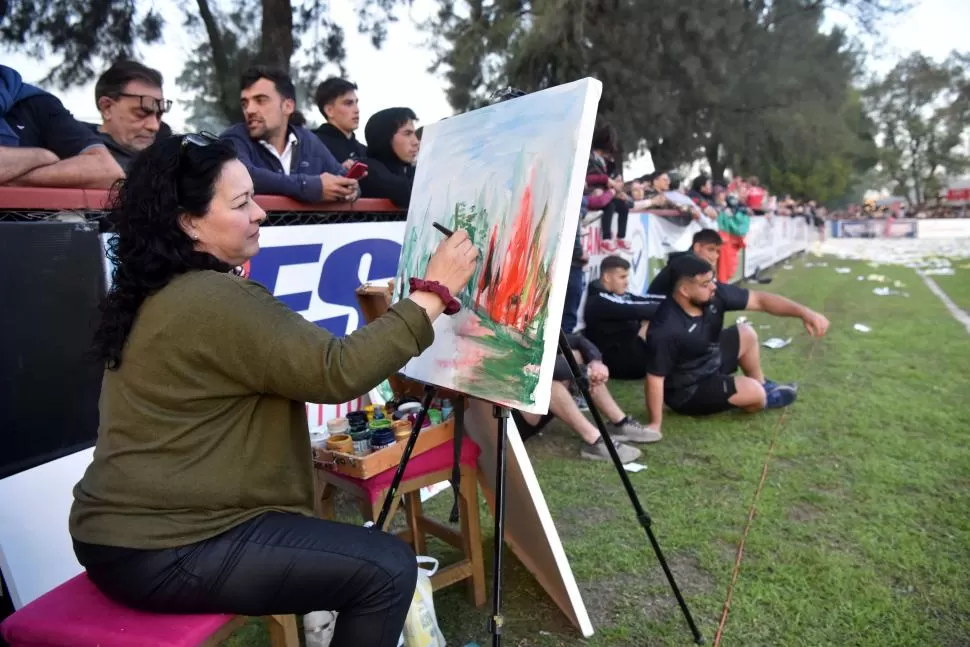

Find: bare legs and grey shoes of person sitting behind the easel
512;335;660;463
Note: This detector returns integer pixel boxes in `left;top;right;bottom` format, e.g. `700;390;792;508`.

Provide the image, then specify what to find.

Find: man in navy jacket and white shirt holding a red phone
222;66;363;202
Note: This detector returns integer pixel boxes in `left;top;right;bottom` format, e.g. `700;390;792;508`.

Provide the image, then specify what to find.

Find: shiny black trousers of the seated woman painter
75;512;417;647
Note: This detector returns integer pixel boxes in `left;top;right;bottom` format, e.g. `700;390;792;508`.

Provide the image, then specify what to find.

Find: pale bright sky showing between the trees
2;0;970;176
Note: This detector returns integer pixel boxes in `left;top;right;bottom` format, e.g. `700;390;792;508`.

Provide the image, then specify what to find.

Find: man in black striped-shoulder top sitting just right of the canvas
583;256;664;380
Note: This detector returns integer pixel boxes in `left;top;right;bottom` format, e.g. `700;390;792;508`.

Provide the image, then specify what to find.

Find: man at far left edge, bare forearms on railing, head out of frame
0;65;125;189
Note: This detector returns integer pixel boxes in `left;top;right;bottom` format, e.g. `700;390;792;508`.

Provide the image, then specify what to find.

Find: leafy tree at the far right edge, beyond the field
866;53;970;204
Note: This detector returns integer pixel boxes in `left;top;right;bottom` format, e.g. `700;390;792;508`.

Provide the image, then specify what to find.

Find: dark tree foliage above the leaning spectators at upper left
0;0;404;128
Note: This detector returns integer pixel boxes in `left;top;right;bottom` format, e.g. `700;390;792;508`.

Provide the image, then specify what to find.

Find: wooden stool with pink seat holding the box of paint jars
314;436;485;606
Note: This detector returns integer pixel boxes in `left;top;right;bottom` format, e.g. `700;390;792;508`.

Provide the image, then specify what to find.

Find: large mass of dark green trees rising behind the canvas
426;0;902;182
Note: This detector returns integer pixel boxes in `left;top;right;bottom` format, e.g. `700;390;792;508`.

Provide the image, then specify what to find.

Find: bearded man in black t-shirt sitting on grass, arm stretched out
646;254;829;431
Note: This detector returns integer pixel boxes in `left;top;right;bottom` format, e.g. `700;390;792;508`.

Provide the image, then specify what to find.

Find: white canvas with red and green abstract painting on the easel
394;79;602;413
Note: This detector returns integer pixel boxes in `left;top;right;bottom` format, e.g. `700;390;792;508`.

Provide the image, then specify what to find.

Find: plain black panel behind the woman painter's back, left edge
0;221;105;480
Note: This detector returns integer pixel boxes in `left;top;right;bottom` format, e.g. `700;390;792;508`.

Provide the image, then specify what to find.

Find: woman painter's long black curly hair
94;137;236;369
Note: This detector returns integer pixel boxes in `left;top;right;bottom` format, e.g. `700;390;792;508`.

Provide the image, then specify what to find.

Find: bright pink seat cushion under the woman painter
0;573;234;647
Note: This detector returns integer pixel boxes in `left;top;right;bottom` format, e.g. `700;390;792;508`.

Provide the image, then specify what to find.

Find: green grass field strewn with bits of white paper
221;254;970;647
